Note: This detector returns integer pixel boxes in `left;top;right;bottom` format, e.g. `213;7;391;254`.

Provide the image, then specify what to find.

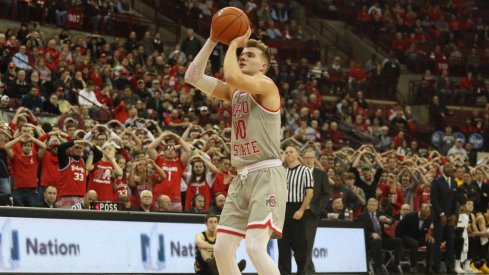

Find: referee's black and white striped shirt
287;165;314;202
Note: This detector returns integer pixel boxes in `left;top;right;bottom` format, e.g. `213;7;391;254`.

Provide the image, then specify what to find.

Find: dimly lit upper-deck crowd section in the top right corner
313;0;489;105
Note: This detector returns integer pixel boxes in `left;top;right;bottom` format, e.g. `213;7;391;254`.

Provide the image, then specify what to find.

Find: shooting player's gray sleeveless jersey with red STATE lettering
231;91;280;169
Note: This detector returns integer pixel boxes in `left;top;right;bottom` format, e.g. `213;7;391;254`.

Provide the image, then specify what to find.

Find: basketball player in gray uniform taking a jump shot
185;27;287;275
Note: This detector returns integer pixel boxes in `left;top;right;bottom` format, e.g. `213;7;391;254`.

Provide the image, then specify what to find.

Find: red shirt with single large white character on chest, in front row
154;157;185;201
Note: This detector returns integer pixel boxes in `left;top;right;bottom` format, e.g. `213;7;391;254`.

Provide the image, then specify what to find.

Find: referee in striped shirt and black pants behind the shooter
278;146;314;275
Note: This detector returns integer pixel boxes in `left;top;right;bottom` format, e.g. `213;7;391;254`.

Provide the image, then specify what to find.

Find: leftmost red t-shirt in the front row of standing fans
12;151;39;190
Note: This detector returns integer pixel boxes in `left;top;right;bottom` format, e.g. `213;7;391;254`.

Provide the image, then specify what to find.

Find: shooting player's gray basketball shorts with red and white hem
217;166;287;238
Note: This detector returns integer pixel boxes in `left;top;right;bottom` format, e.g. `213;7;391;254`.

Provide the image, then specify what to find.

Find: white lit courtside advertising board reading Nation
0;217;366;274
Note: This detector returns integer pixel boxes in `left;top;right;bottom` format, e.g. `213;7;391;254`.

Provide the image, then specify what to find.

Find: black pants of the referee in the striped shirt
278;202;307;275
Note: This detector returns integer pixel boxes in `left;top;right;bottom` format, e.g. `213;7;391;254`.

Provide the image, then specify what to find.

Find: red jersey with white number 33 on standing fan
58;156;87;198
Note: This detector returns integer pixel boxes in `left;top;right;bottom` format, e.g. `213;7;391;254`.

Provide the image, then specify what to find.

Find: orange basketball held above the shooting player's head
212;7;250;45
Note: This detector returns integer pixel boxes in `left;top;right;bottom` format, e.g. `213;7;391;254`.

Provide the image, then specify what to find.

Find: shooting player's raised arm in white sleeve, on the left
185;30;231;101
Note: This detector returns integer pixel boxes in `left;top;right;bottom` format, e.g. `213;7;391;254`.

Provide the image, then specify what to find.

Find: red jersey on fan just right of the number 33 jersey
88;160;114;201
